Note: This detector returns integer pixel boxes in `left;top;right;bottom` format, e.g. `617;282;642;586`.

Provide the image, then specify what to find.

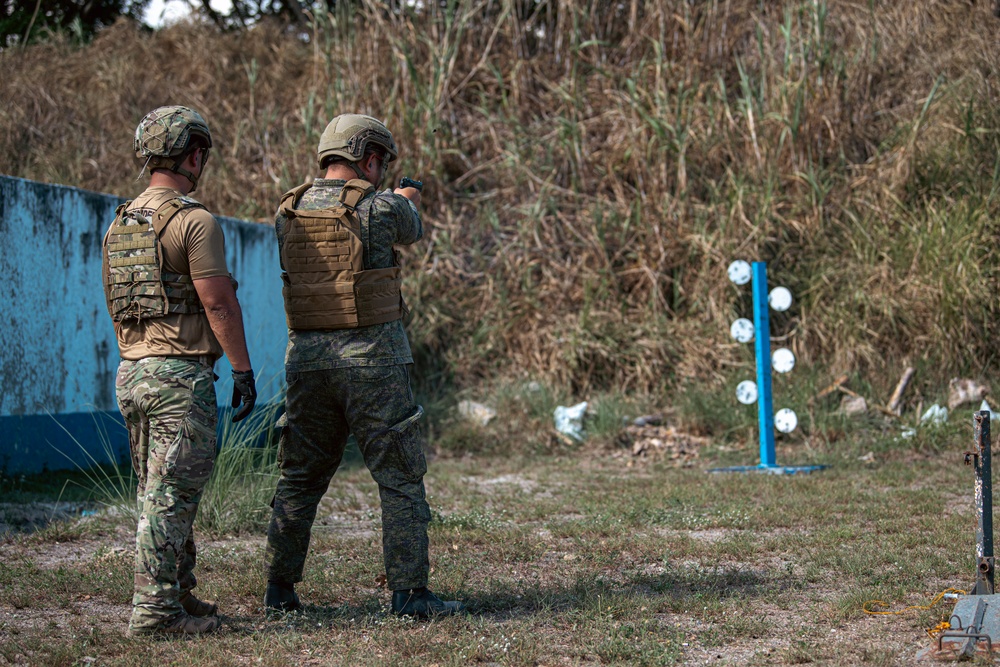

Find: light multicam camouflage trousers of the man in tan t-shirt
115;357;218;629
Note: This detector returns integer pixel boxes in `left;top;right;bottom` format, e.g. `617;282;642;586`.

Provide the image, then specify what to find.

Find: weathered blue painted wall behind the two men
0;176;288;473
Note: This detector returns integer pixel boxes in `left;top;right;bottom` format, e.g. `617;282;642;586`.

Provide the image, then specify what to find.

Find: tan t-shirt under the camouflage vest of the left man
116;187;229;361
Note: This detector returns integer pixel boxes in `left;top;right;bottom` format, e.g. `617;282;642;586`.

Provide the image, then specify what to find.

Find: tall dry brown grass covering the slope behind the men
0;0;1000;402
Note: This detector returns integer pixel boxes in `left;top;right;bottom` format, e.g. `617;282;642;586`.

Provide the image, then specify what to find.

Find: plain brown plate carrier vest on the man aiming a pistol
279;179;404;330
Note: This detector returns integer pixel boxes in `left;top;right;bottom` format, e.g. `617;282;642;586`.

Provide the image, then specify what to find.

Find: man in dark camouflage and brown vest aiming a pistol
264;114;463;617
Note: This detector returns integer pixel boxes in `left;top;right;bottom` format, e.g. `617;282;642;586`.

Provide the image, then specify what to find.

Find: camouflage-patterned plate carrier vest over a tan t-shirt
103;198;204;322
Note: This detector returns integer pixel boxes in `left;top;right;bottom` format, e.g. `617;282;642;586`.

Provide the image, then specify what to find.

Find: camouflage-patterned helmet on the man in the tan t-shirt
132;106;212;192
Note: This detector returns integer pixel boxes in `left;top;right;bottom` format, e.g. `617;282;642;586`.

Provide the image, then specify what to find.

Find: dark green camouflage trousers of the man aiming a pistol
266;366;430;590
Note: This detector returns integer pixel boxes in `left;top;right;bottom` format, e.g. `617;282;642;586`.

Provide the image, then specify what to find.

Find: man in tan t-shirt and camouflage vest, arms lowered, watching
103;106;256;635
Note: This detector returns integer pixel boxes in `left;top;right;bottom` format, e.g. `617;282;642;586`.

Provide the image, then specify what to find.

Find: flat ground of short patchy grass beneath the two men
0;414;974;666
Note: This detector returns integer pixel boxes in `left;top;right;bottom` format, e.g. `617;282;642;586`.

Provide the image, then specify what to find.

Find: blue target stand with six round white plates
708;260;826;475
